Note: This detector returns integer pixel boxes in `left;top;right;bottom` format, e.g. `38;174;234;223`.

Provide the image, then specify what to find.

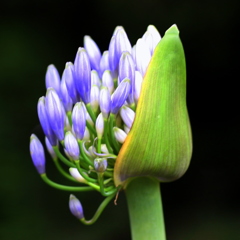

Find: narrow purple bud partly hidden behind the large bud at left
37;97;57;146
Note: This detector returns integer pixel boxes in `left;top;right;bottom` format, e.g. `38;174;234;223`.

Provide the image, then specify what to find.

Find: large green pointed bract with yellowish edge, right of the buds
114;25;192;186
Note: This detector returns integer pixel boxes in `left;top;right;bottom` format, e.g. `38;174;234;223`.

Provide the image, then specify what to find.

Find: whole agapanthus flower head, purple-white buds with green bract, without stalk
30;25;192;223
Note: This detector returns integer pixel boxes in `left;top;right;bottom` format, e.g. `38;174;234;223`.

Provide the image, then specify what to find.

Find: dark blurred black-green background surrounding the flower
0;0;240;240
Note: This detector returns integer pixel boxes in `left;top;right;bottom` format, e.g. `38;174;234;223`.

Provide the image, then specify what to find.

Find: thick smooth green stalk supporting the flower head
125;177;166;240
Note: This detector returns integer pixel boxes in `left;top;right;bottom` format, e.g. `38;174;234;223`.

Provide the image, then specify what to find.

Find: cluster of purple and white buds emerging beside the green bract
30;25;161;218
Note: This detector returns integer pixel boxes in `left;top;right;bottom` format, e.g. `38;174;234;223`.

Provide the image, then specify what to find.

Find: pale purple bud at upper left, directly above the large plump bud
45;64;62;98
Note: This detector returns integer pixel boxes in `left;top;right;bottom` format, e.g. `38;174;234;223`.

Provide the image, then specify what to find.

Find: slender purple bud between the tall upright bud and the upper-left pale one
63;62;80;103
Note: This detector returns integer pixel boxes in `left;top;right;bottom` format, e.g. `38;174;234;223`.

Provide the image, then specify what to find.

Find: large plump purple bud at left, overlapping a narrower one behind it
46;88;65;141
